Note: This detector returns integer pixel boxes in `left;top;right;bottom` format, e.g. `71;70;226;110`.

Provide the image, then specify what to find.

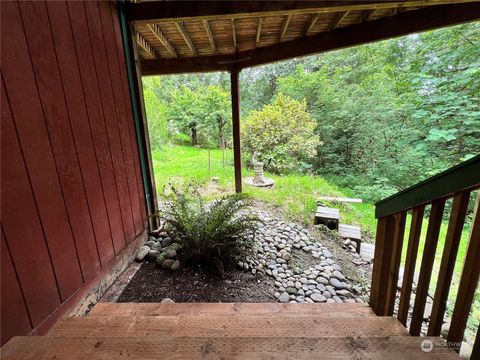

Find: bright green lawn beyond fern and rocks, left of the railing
152;146;376;234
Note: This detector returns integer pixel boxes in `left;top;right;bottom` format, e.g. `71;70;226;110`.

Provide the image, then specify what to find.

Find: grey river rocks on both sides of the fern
136;206;368;303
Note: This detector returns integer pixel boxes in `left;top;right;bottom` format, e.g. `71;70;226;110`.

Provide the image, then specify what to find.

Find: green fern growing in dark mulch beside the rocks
161;188;260;273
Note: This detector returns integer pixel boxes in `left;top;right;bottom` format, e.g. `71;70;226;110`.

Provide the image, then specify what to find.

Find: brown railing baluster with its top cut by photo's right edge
448;191;480;342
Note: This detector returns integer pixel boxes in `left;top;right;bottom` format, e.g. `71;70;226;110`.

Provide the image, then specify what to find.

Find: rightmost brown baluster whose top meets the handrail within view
427;190;470;336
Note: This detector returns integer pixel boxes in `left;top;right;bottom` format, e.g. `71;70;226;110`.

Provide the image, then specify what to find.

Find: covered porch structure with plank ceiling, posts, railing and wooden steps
2;0;480;359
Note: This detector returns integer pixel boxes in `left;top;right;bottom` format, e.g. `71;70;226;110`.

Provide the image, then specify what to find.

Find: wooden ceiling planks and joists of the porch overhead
129;0;480;74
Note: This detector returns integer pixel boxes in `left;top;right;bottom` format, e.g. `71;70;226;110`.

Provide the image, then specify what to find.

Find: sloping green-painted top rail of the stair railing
375;155;480;218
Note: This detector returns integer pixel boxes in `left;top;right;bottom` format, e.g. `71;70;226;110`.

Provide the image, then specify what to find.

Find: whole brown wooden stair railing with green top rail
370;155;480;350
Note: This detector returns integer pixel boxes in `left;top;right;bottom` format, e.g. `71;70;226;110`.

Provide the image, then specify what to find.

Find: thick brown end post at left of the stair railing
370;213;405;316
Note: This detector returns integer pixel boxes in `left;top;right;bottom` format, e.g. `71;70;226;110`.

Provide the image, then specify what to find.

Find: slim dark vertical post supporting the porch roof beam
230;69;242;193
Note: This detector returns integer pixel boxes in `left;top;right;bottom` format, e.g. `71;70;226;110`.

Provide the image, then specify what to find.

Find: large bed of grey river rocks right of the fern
237;210;365;303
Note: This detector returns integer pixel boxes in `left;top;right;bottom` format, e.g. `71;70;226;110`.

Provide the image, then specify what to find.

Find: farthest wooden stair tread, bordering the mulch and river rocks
88;303;376;317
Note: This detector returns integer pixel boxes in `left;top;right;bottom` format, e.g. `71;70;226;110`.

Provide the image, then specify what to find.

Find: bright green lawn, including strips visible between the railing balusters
152;145;480;340
